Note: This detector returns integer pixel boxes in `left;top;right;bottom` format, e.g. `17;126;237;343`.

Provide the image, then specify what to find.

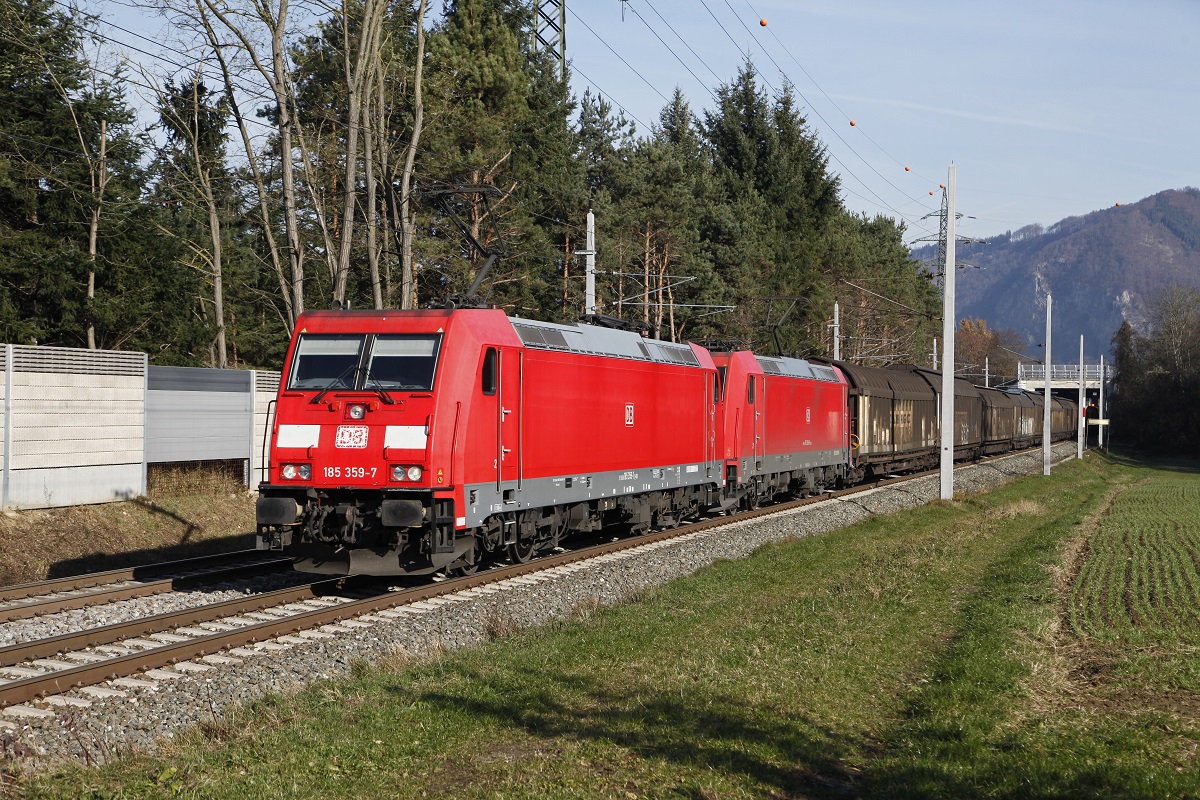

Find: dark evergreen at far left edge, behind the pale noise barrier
0;0;144;347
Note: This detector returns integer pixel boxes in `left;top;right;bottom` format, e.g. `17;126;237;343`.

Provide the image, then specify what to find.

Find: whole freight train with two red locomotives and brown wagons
257;308;1076;576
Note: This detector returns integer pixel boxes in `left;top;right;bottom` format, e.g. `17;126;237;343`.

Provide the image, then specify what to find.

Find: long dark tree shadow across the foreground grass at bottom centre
392;666;870;798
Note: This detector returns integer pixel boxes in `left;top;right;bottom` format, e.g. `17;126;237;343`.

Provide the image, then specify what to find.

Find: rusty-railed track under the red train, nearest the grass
0;443;1051;716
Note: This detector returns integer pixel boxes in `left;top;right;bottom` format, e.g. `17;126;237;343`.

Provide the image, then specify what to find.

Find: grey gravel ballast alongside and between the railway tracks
0;441;1076;769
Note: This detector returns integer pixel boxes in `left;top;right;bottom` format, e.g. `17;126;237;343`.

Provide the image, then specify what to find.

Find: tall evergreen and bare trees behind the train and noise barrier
0;0;940;369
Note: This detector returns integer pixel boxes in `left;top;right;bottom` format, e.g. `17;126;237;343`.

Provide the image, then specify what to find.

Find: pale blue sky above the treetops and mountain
96;0;1200;242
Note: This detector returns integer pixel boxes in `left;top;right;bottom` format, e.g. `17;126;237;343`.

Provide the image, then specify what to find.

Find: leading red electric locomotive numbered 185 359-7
258;309;724;575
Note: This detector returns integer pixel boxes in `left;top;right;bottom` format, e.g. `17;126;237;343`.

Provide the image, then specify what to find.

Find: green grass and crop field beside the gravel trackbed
9;456;1200;799
